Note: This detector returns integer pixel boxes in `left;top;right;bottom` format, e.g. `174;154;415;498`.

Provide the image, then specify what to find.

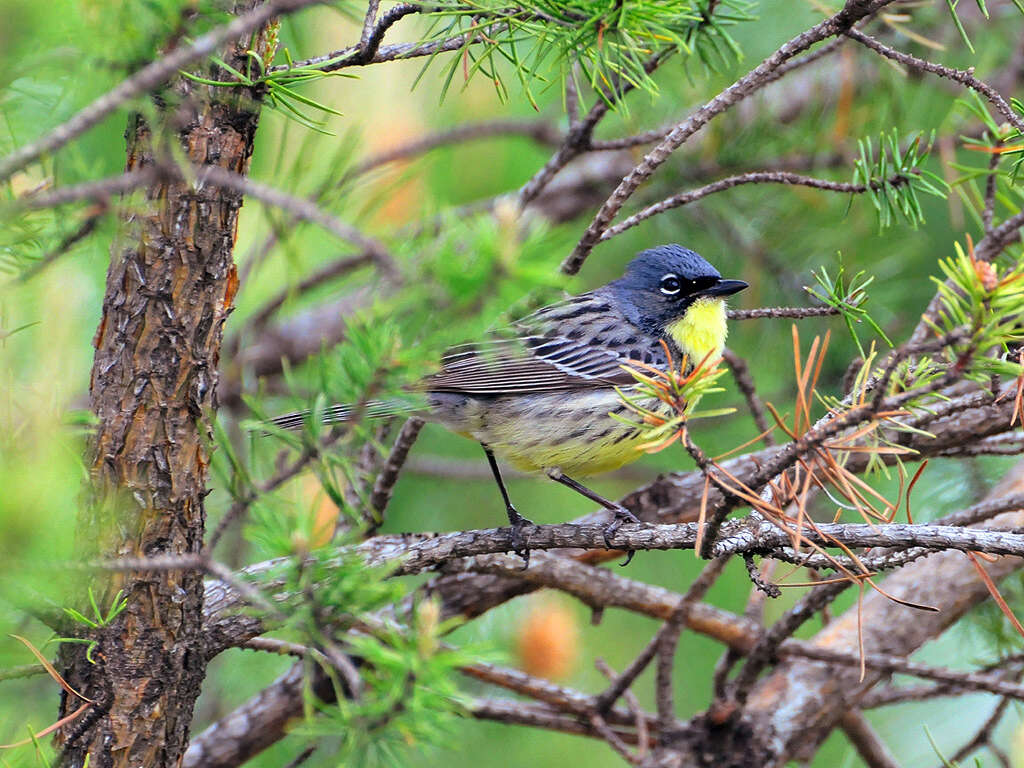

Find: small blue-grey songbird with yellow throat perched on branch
272;245;746;558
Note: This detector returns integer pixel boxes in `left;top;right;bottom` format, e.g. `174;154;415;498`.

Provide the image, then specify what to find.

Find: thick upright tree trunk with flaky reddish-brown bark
57;0;266;768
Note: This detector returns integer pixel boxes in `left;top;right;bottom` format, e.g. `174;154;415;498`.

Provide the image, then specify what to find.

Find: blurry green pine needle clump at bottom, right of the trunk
253;550;468;766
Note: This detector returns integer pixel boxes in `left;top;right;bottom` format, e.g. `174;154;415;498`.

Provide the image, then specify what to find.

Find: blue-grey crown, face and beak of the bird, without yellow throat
609;244;746;333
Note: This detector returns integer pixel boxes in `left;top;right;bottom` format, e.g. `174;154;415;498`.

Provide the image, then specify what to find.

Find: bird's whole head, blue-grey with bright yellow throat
610;245;746;362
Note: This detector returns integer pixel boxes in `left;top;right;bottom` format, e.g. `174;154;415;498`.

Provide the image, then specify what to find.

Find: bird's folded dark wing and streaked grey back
424;294;648;395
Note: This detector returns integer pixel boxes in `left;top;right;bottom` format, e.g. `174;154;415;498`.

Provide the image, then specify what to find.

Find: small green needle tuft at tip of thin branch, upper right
853;128;949;231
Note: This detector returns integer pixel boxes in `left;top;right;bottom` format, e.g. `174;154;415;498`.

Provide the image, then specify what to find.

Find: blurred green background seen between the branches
0;0;1024;768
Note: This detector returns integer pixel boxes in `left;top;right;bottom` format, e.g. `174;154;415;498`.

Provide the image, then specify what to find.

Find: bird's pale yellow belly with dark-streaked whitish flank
430;389;656;476
